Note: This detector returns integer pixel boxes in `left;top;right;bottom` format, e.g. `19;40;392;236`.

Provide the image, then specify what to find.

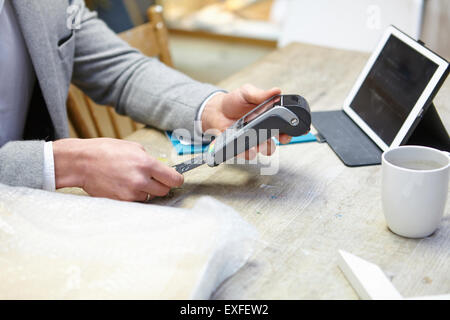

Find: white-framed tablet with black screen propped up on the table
343;26;449;151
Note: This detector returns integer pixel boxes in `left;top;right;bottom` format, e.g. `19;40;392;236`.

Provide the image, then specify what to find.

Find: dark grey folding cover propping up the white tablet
312;104;450;167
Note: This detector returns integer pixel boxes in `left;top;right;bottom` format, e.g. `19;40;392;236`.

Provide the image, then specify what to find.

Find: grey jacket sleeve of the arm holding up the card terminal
73;9;219;132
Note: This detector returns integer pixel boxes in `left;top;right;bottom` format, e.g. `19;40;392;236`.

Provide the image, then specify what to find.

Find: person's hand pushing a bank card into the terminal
53;138;183;201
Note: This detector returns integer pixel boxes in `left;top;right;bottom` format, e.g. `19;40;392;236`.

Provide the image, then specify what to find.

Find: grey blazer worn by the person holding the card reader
0;0;218;188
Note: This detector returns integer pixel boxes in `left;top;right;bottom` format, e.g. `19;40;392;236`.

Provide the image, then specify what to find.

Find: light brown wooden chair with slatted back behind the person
67;5;173;139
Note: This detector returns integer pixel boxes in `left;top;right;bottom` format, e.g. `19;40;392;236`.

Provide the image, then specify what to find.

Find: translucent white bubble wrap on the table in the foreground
0;184;257;299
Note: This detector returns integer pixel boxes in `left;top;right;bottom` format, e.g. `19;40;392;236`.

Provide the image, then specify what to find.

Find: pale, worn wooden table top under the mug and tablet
124;44;450;299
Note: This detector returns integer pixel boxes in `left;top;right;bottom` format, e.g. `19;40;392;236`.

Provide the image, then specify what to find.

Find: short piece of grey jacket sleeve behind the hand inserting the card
0;141;44;189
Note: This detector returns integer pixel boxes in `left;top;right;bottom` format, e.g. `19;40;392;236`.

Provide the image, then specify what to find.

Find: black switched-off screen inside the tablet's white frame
350;35;438;146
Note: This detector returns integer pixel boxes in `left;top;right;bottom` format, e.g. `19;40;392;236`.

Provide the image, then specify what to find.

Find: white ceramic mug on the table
382;146;450;238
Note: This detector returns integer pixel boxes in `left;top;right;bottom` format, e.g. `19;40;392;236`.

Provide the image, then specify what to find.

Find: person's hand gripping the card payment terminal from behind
201;84;291;159
